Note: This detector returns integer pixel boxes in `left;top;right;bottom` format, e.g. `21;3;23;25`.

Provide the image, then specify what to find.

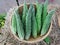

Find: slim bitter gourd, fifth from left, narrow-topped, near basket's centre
32;6;37;38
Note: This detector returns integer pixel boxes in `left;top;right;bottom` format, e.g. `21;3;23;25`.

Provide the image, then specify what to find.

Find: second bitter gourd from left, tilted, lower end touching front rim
15;9;24;39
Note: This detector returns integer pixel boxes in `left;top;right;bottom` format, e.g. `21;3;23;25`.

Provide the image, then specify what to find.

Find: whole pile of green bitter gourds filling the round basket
11;0;55;40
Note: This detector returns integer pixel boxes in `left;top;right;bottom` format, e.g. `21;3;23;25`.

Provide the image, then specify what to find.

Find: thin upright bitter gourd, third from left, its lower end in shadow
22;0;28;34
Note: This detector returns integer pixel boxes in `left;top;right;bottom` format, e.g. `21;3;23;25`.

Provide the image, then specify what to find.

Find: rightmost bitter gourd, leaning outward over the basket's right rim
41;9;55;36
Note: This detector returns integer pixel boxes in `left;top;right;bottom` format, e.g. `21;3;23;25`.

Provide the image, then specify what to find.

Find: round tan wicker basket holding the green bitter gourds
7;4;52;43
